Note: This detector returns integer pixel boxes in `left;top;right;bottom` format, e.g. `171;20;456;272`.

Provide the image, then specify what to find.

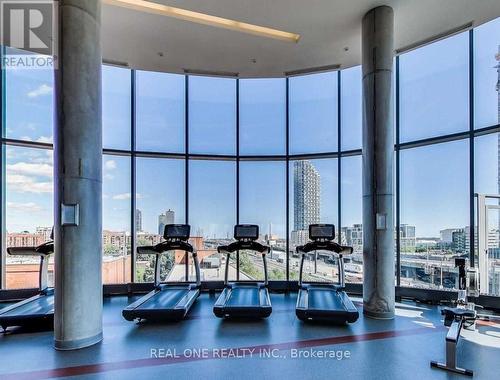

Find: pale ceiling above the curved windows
102;0;500;77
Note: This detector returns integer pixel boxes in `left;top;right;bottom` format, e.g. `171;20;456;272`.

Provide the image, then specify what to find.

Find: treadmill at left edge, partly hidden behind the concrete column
0;231;54;332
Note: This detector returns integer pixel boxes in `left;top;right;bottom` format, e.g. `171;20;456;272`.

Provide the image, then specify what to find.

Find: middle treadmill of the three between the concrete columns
214;224;272;318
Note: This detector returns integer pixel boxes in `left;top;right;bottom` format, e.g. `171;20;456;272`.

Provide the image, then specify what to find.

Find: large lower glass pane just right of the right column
400;140;470;289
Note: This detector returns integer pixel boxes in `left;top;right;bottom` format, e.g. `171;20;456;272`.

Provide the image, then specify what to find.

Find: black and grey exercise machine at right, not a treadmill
431;258;479;376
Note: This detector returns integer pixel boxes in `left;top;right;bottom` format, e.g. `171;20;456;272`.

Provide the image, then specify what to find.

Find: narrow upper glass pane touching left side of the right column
340;66;363;151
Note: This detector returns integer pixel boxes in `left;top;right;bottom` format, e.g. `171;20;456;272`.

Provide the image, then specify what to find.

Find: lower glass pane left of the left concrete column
4;146;54;289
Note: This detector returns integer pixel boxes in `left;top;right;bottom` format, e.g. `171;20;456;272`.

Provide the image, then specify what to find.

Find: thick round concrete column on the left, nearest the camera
54;0;102;350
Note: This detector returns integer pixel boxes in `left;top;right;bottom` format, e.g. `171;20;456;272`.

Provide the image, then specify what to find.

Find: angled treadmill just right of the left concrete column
122;224;201;321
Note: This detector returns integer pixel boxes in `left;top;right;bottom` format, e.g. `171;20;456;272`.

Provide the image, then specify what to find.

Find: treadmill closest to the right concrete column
295;224;359;324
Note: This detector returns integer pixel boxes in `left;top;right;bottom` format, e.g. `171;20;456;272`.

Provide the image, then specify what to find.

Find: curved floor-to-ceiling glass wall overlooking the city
2;19;500;295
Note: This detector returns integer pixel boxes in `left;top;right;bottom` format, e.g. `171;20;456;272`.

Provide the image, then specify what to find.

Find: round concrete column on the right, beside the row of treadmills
362;6;395;319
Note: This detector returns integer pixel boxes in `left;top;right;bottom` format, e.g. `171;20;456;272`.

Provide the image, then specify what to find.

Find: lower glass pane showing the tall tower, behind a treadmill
289;159;338;281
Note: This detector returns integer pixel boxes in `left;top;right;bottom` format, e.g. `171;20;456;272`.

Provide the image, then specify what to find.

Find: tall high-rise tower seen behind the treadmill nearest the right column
292;160;321;244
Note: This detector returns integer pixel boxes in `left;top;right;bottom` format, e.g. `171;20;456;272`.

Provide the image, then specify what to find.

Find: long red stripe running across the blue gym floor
2;327;444;380
